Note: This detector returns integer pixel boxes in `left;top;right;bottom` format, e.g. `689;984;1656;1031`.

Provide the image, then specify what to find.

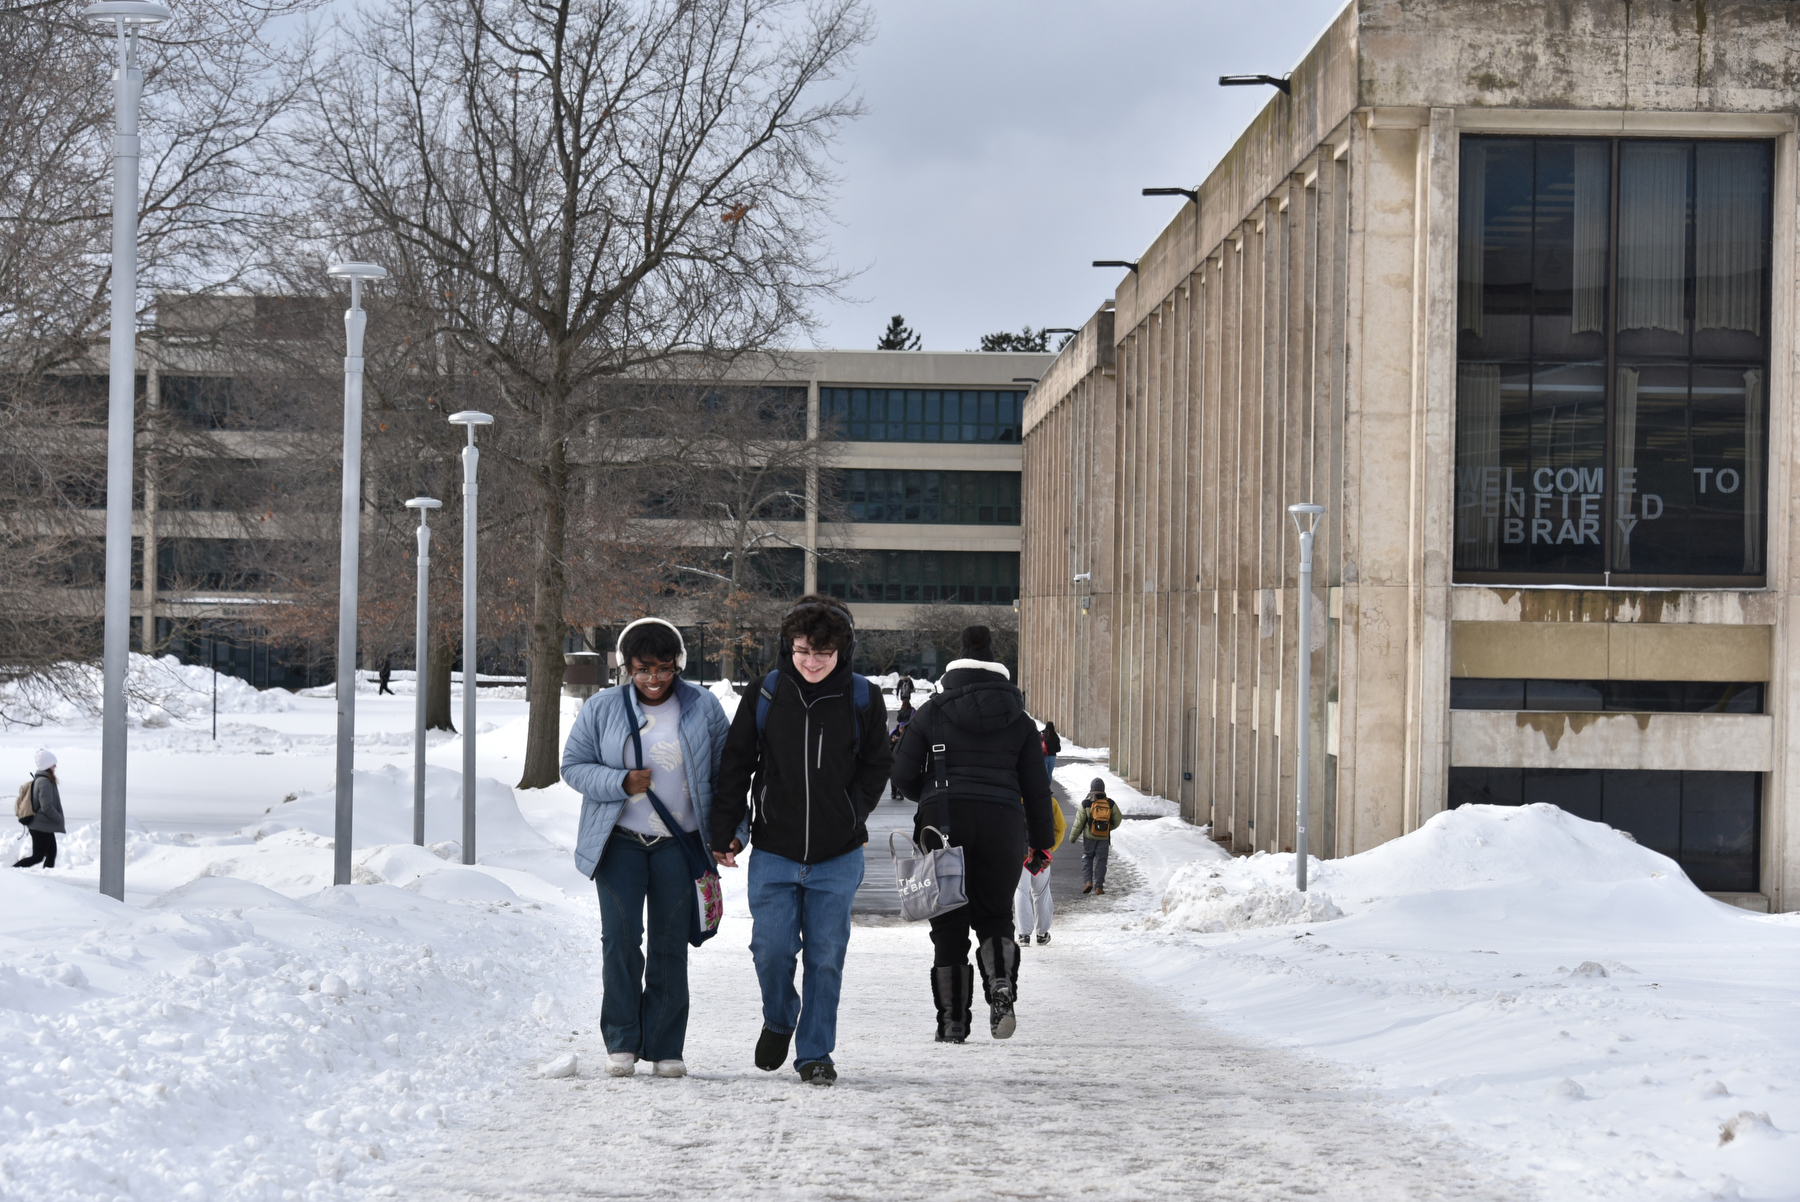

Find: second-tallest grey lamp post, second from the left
326;263;387;885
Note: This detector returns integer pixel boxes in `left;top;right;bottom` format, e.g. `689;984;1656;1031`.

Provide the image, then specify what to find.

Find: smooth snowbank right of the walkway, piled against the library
1094;806;1800;1202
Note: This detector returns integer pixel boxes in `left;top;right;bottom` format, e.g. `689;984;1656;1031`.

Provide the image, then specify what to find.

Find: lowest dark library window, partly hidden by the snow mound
1451;768;1762;893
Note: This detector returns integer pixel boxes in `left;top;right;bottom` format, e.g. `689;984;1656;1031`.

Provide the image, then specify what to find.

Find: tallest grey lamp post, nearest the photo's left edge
81;0;171;902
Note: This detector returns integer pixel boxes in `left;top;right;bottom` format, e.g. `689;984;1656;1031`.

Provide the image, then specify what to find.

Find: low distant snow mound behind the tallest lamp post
0;653;293;729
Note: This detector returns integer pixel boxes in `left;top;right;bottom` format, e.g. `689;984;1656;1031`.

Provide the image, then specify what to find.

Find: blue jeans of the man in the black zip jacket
749;848;862;1069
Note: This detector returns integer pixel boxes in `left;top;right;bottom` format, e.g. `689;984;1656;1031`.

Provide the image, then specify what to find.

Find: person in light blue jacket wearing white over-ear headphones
562;617;729;1076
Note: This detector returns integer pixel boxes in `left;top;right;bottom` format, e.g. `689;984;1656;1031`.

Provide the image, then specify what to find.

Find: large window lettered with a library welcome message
1456;137;1771;583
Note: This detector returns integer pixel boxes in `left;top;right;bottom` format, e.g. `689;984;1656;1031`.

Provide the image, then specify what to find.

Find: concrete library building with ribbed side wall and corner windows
1021;0;1800;910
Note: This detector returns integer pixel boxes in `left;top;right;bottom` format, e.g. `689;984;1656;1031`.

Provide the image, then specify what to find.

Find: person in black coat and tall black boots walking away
893;626;1057;1044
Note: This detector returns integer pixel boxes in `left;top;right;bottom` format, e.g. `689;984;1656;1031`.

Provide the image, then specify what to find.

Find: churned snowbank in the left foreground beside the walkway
0;869;598;1200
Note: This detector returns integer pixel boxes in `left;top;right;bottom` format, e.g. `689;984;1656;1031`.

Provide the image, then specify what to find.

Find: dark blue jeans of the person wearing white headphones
594;826;695;1062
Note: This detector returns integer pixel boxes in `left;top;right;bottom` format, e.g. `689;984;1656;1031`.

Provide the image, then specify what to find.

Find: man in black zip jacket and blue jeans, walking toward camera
713;594;893;1085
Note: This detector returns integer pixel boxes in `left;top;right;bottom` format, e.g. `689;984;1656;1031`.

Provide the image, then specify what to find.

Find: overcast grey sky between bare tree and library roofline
819;0;1343;351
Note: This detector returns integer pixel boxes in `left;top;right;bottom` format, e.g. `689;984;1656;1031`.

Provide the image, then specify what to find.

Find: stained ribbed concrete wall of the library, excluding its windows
1026;0;1800;909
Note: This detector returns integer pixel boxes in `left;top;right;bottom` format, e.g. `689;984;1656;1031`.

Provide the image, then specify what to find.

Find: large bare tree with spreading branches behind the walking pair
295;0;869;788
